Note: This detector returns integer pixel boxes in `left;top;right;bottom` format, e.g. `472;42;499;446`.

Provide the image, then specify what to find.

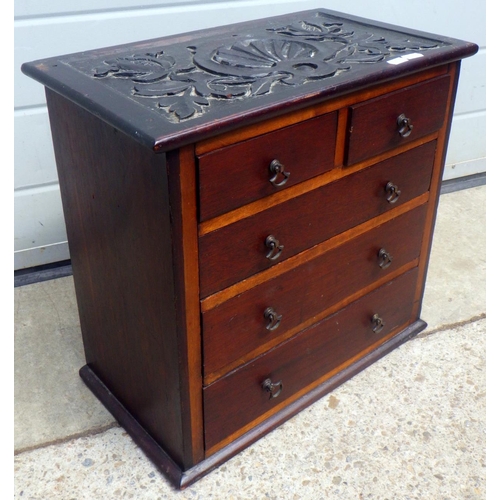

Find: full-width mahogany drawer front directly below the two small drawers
199;141;436;297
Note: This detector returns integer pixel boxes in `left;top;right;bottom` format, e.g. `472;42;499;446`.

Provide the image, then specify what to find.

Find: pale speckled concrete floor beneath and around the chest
14;186;486;500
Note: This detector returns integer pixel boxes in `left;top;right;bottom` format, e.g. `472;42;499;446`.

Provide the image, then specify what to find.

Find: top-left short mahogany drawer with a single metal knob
198;112;337;221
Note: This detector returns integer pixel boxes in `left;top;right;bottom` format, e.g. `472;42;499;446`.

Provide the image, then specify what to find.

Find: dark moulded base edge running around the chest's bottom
80;319;427;489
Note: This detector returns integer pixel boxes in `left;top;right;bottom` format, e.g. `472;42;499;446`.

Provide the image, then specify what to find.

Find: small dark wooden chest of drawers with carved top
23;10;477;488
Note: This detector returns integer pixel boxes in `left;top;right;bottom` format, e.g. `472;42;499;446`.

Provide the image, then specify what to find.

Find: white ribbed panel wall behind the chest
14;0;486;269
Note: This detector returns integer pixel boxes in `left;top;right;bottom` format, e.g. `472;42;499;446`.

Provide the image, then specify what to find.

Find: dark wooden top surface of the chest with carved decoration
23;10;473;149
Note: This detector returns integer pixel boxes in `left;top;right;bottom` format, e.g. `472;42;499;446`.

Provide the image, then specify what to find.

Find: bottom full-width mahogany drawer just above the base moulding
203;268;418;449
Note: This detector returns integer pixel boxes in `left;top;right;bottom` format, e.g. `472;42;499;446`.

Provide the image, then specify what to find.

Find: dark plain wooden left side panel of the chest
47;90;197;467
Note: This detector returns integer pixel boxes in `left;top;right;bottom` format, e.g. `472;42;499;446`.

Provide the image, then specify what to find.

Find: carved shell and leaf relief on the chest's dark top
93;13;442;121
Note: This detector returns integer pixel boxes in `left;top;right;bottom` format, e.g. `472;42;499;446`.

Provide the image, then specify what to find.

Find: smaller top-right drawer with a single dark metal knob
345;75;450;165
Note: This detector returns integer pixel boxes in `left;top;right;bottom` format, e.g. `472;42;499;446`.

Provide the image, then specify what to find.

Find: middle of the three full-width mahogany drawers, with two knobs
202;204;427;376
